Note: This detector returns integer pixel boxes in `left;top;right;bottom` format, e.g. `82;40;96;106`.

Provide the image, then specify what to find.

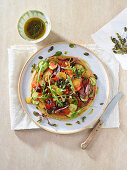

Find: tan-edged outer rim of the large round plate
18;41;110;134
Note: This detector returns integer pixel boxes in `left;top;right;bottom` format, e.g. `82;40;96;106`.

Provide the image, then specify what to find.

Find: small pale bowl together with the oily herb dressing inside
17;10;51;43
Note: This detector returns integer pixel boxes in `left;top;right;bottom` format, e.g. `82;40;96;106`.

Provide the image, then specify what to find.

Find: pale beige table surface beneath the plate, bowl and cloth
0;0;127;170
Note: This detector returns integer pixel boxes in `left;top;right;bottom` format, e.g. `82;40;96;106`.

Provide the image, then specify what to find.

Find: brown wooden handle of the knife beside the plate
81;120;103;150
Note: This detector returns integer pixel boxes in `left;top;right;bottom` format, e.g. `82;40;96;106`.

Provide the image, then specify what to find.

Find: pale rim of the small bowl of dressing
17;10;51;43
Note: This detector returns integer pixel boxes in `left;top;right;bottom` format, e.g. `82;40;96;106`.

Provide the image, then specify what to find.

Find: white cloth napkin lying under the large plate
8;44;119;130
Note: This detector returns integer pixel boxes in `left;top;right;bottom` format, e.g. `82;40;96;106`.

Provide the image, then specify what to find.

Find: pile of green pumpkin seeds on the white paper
110;27;127;54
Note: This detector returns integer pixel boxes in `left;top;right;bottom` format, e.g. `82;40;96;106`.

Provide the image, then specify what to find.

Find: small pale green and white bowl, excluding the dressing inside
17;10;51;43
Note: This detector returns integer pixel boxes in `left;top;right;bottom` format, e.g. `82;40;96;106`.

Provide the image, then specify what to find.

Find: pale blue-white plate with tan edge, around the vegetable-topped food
19;42;110;134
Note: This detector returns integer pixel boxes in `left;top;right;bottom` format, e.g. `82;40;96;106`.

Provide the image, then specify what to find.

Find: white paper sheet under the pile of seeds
91;8;127;70
